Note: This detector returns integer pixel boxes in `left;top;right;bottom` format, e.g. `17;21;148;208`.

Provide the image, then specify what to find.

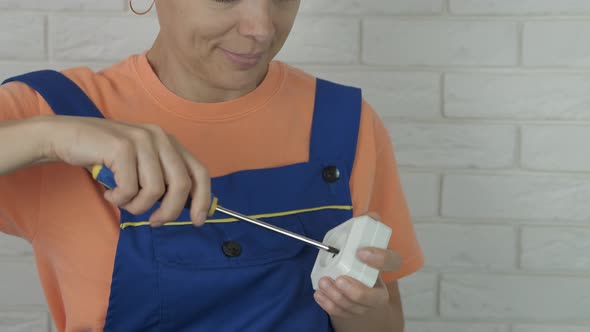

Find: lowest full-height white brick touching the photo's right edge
440;273;590;322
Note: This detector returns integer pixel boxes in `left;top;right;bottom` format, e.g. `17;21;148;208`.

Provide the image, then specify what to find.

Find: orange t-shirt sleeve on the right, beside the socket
350;102;424;282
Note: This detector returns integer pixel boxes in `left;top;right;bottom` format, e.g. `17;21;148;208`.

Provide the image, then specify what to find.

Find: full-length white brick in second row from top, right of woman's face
363;18;518;66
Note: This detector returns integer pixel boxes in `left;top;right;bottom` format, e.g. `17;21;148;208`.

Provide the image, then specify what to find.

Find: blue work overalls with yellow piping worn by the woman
7;71;361;332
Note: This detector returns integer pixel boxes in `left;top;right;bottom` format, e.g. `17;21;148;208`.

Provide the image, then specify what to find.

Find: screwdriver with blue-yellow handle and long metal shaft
92;165;340;255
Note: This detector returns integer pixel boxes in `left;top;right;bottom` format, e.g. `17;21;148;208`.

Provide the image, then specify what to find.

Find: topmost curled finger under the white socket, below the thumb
335;276;389;309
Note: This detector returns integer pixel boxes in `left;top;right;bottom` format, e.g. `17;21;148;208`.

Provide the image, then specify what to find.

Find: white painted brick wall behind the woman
0;0;590;332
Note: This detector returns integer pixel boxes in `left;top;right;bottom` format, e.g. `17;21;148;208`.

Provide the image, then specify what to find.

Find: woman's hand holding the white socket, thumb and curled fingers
314;248;401;319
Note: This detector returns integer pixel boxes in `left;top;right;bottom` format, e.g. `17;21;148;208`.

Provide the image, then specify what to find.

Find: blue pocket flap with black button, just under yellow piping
153;215;305;270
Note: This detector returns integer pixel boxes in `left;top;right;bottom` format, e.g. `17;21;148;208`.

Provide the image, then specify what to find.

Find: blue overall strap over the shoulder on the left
2;70;104;118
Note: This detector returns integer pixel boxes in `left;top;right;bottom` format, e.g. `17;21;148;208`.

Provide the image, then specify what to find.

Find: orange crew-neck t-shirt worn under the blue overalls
0;54;423;331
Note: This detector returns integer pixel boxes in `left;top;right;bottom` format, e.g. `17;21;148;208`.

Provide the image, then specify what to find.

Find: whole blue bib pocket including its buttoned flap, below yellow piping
153;215;317;332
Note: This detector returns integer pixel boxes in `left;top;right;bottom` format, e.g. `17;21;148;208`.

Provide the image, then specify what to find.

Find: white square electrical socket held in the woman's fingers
311;216;391;290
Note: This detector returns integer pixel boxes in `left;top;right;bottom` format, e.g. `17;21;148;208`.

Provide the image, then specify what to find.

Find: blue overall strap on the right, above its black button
309;79;362;171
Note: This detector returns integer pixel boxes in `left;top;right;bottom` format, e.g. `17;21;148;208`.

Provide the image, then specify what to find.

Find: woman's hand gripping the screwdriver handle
45;116;211;226
